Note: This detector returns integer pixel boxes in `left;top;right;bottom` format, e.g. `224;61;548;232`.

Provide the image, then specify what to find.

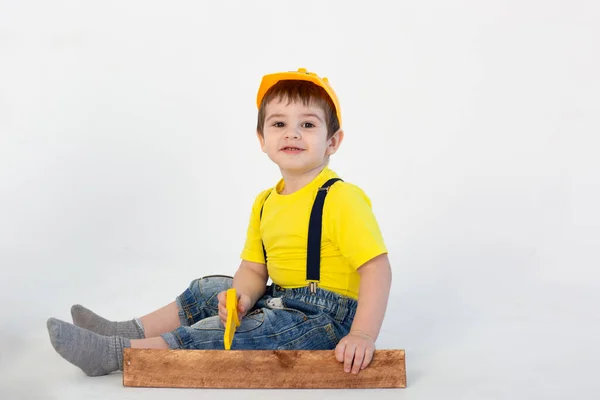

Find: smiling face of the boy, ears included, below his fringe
258;100;343;174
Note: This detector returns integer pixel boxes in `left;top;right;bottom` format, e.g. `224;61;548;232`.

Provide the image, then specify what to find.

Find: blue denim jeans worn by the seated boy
162;275;357;350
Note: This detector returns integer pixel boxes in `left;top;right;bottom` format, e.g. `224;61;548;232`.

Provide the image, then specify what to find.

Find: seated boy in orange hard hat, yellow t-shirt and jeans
47;68;391;376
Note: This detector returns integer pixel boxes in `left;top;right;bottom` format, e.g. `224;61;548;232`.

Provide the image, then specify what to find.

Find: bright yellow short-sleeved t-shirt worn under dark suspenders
241;167;387;299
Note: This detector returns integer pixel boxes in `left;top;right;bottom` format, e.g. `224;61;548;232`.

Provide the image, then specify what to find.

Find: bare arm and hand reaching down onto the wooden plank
335;254;392;374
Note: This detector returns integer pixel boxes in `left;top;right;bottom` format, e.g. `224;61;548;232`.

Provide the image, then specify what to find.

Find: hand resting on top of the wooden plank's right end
335;331;375;374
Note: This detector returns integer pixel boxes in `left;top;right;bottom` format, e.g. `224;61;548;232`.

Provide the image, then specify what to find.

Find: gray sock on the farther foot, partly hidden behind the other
71;304;145;339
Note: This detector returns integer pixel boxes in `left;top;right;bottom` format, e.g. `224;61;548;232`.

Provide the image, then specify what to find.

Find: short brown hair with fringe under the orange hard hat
256;80;340;139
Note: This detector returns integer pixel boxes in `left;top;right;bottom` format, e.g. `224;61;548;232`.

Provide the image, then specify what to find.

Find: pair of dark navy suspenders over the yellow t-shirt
260;178;342;294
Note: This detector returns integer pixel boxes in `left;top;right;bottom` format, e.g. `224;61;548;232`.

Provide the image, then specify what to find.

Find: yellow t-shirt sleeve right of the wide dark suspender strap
323;182;387;269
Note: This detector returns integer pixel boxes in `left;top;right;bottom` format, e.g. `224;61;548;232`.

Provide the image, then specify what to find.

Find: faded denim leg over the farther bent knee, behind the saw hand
176;275;233;326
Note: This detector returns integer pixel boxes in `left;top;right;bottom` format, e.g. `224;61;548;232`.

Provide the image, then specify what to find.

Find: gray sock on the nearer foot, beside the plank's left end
46;318;131;376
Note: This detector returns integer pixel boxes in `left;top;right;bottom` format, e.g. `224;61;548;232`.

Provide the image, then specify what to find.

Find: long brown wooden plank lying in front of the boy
123;348;406;389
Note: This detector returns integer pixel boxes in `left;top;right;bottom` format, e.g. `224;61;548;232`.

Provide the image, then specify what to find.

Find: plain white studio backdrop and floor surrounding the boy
0;0;600;399
